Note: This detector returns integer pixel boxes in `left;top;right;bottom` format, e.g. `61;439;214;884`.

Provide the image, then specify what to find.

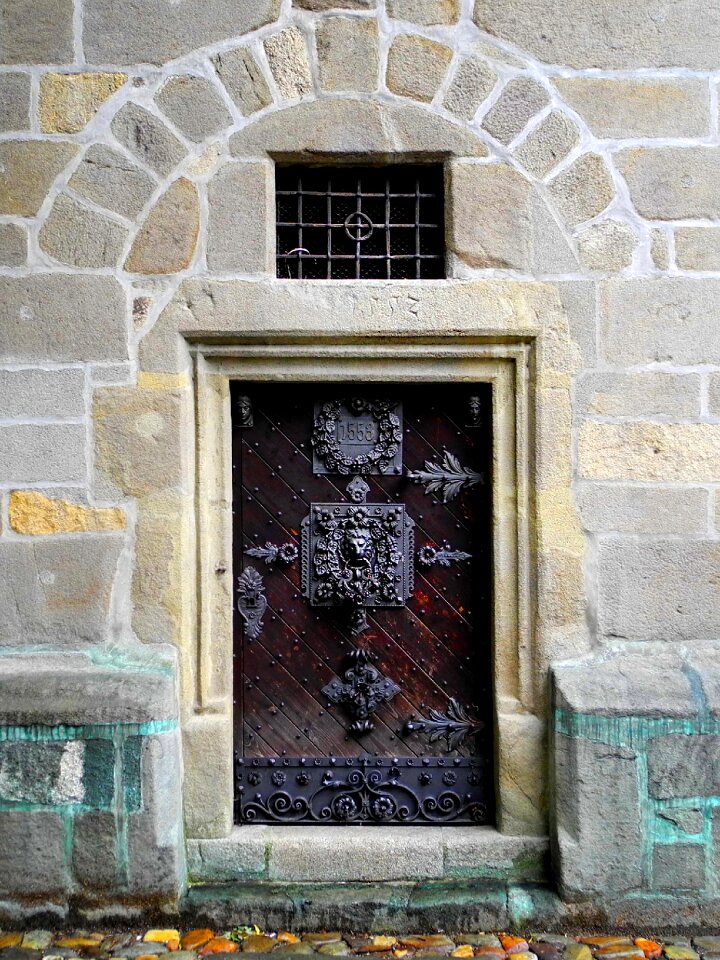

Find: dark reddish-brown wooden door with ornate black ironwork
232;383;493;824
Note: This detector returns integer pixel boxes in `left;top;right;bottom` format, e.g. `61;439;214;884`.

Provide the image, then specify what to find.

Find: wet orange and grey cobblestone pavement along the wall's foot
0;927;720;960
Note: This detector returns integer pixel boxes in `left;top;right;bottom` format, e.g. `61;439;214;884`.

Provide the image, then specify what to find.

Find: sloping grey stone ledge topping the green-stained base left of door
0;648;177;724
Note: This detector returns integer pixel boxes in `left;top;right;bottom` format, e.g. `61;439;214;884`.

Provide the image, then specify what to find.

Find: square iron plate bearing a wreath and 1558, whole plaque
310;397;402;475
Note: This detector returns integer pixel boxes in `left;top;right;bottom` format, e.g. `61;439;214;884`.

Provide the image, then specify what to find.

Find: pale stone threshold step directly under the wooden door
187;825;549;884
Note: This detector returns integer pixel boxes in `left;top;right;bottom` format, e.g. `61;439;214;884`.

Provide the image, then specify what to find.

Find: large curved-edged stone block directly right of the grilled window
448;161;577;273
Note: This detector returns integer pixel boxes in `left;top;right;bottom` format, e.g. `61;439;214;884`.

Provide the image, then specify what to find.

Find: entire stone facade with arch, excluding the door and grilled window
0;0;720;927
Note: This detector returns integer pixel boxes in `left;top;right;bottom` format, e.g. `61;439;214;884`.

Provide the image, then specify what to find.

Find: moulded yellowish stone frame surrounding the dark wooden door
185;337;546;837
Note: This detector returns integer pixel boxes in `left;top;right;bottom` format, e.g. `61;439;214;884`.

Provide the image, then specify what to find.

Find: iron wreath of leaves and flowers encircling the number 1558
311;397;402;474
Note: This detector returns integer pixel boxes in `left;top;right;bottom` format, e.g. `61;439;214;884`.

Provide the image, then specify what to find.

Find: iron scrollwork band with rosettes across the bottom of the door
235;757;492;825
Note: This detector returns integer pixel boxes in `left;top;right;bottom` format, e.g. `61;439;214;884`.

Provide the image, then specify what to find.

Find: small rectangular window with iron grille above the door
275;164;445;280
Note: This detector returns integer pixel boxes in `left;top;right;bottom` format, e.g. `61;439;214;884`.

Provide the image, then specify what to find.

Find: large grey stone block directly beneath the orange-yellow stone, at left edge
0;534;124;644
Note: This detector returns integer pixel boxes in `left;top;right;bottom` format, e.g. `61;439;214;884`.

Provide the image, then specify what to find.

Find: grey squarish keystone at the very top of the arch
315;17;379;91
